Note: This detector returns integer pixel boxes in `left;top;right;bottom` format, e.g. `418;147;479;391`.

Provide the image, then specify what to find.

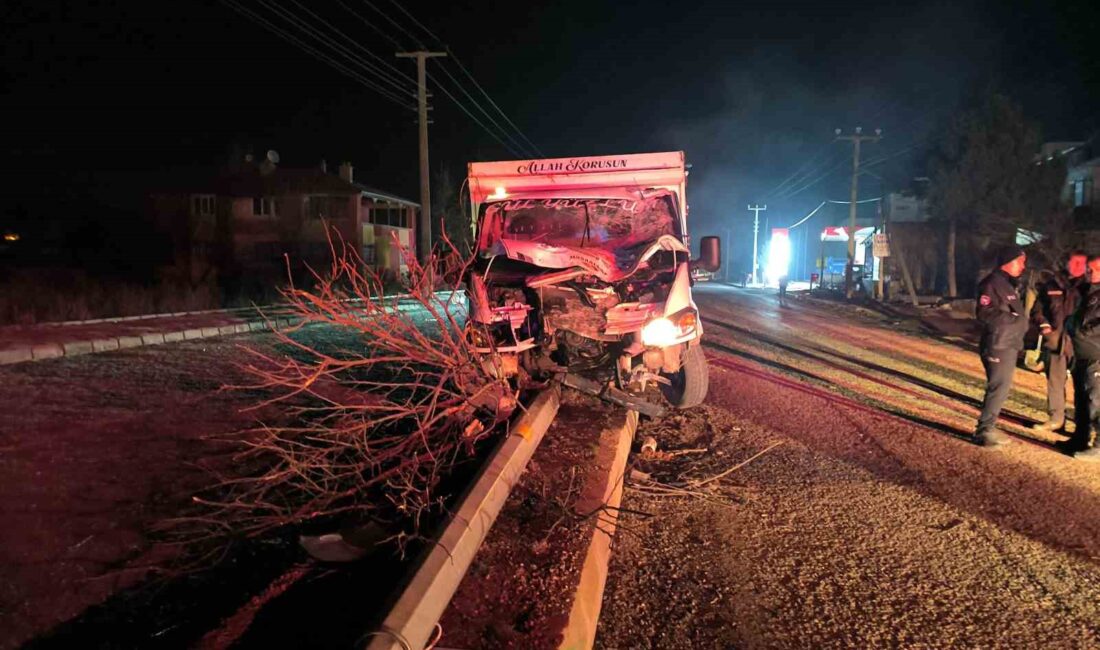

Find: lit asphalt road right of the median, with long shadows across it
597;285;1100;648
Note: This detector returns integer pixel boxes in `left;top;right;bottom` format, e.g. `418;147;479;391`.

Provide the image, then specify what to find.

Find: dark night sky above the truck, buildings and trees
0;0;1100;266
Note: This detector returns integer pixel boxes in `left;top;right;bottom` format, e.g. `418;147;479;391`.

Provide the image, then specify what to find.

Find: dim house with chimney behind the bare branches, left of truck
151;152;420;286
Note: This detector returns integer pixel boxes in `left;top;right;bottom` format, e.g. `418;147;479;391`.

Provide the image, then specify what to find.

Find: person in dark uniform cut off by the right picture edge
1058;255;1100;462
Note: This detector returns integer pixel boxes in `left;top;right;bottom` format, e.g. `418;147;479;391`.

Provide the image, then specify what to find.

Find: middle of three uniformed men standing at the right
1032;251;1088;431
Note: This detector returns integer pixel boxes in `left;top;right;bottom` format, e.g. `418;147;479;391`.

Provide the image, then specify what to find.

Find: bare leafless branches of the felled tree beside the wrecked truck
168;228;516;549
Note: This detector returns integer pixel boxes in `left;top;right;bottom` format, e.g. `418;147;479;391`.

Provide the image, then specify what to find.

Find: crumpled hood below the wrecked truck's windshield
491;234;691;282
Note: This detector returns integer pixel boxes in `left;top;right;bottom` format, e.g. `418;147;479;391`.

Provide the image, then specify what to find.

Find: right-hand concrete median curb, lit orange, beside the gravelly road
559;410;638;650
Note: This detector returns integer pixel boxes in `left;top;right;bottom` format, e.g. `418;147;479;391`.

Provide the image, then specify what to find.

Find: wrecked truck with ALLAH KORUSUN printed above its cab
465;152;721;415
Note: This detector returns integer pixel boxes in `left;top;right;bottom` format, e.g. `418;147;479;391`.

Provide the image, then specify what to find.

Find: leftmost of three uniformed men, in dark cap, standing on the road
972;246;1029;448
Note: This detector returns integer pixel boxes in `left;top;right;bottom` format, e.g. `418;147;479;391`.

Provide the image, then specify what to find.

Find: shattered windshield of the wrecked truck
483;192;679;250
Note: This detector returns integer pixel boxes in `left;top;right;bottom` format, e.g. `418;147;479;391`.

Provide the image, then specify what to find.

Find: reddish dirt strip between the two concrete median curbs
440;392;623;650
